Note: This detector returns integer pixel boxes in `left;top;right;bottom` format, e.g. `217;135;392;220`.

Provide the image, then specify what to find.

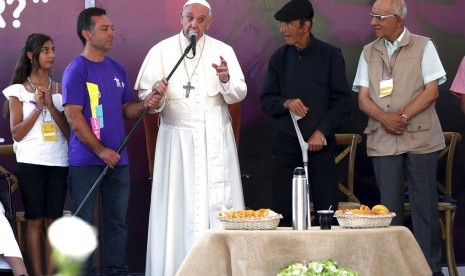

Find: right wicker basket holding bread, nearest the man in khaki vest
334;213;396;228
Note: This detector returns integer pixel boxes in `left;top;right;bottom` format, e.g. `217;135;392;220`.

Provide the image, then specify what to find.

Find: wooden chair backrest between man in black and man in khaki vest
336;133;362;203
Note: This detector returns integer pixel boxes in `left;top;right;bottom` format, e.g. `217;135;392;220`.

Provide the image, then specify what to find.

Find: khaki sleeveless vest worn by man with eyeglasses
363;29;445;156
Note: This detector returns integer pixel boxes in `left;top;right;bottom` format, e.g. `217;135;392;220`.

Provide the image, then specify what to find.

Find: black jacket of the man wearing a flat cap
260;35;351;153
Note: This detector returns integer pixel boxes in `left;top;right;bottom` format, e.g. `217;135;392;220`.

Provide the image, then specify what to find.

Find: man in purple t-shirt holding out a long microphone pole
62;8;162;275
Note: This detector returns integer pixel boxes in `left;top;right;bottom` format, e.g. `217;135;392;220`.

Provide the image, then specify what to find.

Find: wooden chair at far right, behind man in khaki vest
404;132;462;276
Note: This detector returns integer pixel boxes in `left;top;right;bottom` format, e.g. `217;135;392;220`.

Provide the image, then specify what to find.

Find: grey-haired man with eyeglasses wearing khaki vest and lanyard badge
353;0;446;275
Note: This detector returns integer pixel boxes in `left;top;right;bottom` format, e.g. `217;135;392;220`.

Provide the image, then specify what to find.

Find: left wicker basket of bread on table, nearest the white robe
218;214;283;230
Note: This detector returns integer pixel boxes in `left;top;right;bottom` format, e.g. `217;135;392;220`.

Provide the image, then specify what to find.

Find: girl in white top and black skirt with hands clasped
3;33;69;275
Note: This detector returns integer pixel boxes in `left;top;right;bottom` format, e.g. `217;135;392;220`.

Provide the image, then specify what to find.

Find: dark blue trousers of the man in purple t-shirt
68;166;130;275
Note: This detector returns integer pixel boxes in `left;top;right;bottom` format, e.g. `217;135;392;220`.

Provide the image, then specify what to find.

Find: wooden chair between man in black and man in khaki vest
310;133;362;213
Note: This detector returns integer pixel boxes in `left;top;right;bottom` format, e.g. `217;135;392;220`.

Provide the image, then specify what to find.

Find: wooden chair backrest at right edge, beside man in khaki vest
437;132;462;198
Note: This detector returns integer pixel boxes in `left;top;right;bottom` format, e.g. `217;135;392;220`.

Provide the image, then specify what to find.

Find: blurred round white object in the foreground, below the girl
48;216;97;261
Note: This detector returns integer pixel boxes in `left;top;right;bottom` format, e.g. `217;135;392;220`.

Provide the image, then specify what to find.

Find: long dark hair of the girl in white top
3;33;53;119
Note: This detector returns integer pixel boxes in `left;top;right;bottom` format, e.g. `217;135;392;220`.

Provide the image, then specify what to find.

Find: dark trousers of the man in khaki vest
373;152;442;272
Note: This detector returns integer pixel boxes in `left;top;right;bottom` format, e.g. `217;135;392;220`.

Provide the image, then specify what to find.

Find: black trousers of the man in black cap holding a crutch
272;145;339;226
